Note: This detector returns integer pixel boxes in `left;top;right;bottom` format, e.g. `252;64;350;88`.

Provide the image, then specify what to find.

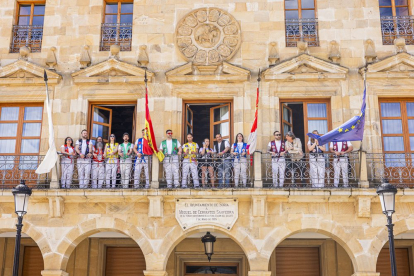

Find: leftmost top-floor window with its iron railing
10;3;45;53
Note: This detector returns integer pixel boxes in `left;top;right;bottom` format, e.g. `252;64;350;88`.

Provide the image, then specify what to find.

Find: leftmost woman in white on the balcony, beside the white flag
60;137;76;189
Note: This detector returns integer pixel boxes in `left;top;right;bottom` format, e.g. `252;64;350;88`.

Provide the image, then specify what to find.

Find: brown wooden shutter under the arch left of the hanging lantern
105;247;146;276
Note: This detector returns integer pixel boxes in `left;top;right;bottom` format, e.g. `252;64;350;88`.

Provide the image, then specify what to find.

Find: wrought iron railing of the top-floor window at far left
10;25;43;53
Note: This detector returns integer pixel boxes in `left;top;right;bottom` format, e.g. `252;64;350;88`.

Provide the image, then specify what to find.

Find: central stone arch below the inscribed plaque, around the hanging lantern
154;225;268;271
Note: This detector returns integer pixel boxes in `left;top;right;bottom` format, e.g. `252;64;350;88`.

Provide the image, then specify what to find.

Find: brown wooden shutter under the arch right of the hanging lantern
276;247;322;276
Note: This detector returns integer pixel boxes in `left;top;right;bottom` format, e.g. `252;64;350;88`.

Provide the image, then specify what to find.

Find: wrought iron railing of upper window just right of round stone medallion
285;18;319;47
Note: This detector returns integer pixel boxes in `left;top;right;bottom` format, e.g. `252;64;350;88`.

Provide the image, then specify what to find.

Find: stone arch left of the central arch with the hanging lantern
53;217;153;270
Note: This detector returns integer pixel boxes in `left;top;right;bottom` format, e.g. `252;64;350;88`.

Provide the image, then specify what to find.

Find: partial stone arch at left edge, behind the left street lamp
0;218;52;266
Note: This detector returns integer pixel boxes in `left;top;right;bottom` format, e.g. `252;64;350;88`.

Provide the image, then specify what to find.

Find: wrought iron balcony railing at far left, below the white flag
0;155;50;189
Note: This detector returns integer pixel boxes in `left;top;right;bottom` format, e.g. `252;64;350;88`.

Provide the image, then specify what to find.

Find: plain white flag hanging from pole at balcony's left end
36;70;58;174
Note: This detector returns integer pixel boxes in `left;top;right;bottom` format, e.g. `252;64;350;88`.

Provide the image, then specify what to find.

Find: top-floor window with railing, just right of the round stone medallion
285;0;319;47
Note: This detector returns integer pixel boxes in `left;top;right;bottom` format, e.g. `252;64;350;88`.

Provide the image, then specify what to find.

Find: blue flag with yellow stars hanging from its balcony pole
308;82;367;145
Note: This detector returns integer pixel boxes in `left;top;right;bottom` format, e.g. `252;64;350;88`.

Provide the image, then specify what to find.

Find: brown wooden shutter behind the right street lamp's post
377;248;411;276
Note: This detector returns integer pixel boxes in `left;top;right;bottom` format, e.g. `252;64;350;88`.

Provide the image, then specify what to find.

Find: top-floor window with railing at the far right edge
379;0;414;45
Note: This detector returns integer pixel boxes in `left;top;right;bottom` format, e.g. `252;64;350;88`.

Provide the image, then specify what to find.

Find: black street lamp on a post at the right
377;180;397;276
